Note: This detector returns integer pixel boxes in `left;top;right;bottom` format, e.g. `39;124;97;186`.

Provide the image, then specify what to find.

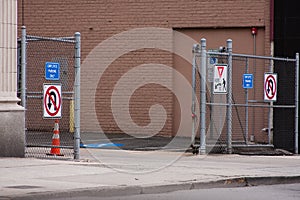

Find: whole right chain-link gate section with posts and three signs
192;39;299;153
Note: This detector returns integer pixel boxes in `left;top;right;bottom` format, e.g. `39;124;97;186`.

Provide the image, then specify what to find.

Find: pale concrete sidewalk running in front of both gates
0;149;300;200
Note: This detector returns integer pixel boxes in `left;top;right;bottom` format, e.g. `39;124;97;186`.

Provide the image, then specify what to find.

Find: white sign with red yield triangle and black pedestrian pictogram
213;64;227;94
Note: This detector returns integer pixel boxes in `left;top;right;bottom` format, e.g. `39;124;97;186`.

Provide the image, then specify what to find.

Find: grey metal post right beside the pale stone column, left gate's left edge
21;26;26;108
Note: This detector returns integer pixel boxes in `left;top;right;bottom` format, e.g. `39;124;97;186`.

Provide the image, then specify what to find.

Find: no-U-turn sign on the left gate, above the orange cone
43;84;62;118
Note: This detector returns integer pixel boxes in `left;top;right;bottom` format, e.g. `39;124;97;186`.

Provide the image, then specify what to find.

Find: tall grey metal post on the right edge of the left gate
74;32;80;160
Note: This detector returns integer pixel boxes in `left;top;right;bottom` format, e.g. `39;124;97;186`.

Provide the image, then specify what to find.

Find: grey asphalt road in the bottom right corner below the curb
54;183;300;200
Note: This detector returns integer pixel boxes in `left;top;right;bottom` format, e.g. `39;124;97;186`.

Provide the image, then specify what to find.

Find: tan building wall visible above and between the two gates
19;0;270;141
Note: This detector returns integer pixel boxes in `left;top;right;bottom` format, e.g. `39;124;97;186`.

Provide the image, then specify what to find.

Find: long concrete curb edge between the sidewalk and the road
8;176;300;200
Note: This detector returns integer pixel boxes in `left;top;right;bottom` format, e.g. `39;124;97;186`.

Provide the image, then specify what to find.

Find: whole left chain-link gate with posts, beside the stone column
18;27;80;159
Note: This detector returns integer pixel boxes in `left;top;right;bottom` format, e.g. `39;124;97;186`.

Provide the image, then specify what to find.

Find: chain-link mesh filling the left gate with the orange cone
25;35;74;158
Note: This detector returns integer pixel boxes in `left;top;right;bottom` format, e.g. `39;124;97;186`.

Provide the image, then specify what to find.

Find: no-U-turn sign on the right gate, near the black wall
264;73;277;101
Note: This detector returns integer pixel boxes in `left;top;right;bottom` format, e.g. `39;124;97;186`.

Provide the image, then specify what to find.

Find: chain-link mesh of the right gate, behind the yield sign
193;52;296;152
